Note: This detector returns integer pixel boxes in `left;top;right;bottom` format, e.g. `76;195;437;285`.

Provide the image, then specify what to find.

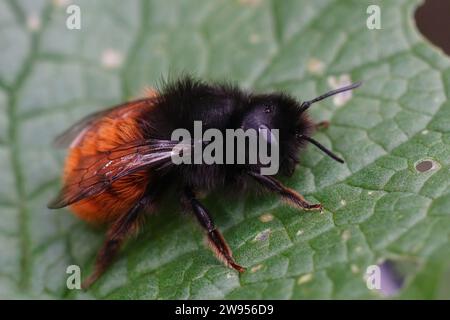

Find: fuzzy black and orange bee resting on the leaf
48;76;361;288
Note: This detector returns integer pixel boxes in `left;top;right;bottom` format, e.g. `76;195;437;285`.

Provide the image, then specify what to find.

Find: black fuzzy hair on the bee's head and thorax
141;76;313;191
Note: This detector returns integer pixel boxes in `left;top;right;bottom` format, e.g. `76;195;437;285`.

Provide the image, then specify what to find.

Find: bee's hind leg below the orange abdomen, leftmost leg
82;198;149;289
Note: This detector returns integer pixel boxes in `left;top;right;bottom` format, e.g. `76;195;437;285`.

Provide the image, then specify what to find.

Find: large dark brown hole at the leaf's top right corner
415;0;450;55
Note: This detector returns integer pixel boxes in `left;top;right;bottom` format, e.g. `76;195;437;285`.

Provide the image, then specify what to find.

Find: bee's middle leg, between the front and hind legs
182;189;245;272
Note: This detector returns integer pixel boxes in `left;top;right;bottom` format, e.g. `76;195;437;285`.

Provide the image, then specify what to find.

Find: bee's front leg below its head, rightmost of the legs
248;171;323;211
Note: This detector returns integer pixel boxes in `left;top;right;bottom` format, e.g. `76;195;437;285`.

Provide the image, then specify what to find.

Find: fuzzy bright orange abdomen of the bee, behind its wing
64;106;150;223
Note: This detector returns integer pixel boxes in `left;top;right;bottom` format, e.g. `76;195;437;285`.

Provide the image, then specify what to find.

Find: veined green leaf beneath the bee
0;0;450;299
